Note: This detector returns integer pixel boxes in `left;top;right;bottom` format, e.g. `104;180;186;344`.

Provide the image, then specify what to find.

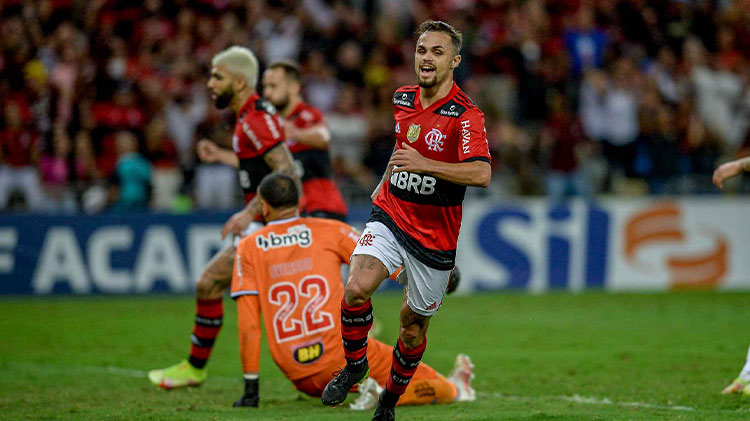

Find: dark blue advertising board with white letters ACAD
0;212;231;295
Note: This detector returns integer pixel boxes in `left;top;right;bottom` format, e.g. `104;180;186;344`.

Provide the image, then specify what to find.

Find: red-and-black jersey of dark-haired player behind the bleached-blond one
286;101;347;218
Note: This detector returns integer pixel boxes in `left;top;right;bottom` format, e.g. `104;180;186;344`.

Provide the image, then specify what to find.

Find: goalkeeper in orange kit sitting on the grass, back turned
231;174;475;409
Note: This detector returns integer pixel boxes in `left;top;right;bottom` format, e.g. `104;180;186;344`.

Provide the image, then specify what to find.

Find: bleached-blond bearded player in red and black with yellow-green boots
148;46;297;389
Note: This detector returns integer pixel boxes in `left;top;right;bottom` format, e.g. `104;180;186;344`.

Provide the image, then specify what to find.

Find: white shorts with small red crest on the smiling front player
352;222;452;316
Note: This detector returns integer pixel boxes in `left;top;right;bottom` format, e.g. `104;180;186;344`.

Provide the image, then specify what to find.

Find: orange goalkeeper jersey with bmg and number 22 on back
232;218;359;381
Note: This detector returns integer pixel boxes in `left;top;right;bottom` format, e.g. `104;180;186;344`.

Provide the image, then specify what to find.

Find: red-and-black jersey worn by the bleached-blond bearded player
232;94;285;203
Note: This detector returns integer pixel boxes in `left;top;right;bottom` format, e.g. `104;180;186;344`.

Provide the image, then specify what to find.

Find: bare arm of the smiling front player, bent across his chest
389;143;492;187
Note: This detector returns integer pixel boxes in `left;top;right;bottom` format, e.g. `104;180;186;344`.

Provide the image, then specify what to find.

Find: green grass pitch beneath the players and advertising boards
0;292;750;421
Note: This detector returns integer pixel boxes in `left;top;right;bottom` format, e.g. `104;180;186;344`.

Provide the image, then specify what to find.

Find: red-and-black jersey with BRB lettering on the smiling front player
370;82;490;270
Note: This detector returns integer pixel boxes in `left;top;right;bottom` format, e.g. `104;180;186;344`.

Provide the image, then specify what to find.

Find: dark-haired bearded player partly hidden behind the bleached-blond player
261;60;347;221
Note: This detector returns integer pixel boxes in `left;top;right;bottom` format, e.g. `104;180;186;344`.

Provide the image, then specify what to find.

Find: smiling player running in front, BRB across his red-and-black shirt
321;21;491;420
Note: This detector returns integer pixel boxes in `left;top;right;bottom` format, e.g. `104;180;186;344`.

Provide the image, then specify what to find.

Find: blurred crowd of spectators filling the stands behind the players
0;0;750;212
